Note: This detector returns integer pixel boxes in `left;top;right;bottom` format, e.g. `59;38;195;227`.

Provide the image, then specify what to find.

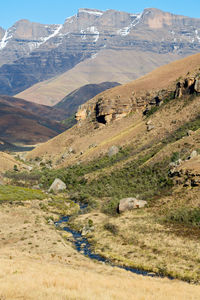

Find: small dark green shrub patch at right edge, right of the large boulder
163;207;200;227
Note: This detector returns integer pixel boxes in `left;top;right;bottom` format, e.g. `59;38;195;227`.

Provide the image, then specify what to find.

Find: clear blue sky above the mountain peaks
0;0;200;29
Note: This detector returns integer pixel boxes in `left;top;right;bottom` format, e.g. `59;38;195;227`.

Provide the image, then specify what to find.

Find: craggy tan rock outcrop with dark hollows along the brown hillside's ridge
76;74;200;124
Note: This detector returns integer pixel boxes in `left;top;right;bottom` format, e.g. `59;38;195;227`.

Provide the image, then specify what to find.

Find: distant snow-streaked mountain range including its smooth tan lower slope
0;8;200;105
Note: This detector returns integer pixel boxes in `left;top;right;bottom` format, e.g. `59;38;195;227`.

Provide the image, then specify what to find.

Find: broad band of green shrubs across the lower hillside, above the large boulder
4;145;172;215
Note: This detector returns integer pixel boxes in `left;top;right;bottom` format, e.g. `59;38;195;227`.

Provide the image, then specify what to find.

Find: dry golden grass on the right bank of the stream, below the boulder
72;207;200;281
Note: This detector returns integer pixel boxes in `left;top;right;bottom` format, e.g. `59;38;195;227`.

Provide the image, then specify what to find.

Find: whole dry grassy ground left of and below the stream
0;200;200;300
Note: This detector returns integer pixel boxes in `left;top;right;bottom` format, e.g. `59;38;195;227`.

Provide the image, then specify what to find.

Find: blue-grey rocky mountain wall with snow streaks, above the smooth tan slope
0;9;200;95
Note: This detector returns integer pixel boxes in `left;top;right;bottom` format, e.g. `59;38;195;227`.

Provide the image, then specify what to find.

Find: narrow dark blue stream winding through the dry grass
55;203;173;279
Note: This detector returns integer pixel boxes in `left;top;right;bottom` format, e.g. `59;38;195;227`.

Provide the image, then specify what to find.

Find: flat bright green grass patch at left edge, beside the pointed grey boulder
0;185;46;203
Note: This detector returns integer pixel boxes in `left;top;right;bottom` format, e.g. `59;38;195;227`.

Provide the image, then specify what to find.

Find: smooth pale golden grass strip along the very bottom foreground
0;253;200;300
